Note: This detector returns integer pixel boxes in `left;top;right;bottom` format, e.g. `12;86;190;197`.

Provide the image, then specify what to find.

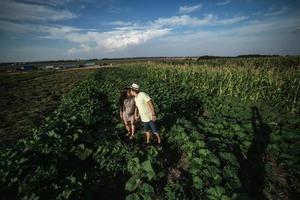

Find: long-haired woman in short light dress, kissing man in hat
119;88;137;139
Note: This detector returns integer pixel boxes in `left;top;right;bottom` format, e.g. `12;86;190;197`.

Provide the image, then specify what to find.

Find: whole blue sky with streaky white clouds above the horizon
0;0;300;62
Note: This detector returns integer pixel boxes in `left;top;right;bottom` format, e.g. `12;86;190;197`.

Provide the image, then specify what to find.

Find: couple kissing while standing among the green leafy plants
119;83;161;144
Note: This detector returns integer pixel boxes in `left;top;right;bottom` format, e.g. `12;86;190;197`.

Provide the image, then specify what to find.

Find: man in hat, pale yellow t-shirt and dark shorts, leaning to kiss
130;83;161;144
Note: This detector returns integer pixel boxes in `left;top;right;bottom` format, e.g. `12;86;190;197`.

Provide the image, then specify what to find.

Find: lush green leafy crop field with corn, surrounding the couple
0;57;300;200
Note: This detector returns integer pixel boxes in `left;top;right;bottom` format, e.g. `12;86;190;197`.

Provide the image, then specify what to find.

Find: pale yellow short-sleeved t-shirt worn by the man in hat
134;92;152;122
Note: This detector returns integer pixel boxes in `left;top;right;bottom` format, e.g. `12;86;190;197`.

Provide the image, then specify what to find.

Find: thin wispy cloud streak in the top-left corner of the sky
0;0;77;22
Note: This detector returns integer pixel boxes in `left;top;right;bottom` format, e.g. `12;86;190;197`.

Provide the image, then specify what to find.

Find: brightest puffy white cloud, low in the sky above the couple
41;23;171;54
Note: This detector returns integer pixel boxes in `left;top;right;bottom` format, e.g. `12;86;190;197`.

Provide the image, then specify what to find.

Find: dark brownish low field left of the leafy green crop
0;69;101;146
